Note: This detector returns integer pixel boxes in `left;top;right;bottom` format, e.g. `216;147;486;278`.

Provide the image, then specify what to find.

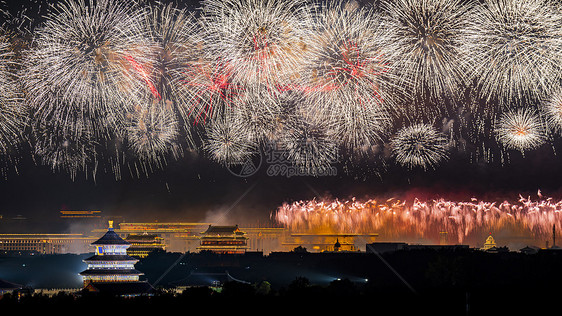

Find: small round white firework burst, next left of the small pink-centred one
390;123;449;170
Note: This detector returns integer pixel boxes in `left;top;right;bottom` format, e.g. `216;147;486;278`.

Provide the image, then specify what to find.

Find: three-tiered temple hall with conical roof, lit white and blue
80;221;151;295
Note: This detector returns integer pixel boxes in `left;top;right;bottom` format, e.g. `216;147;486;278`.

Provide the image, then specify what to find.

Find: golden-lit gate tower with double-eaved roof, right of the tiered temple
198;225;248;254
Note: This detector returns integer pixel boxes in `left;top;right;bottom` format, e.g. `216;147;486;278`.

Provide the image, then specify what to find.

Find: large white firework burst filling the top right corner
462;0;562;107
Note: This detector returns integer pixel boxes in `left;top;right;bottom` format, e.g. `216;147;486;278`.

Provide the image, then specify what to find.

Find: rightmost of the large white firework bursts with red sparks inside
298;2;394;151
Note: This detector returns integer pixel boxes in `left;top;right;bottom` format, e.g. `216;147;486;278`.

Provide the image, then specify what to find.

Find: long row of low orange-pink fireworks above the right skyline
272;196;562;243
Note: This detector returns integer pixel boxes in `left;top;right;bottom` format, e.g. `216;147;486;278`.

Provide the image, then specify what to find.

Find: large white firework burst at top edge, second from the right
382;0;471;107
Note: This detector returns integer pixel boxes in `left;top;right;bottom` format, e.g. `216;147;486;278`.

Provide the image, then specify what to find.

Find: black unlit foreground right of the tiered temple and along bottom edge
0;250;562;315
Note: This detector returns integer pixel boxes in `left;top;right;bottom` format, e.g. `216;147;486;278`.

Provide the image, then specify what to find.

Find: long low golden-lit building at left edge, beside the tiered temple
0;234;95;255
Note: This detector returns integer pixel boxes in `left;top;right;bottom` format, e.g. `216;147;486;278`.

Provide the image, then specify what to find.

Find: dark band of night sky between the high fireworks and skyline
0;0;562;232
